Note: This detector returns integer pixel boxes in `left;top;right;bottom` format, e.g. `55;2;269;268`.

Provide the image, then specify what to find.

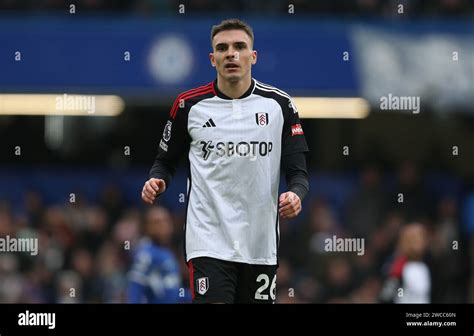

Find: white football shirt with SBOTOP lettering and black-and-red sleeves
152;79;308;265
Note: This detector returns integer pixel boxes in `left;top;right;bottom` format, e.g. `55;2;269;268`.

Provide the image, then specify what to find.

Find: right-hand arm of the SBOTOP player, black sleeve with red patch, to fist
278;99;309;219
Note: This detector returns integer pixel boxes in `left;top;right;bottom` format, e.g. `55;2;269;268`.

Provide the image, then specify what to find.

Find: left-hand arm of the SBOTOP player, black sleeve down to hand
142;95;191;204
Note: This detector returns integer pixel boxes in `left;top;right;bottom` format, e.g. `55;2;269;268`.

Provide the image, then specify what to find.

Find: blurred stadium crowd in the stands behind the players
0;163;474;303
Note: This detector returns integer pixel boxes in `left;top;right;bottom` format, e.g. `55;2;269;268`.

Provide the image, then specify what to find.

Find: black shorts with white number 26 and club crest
188;257;277;303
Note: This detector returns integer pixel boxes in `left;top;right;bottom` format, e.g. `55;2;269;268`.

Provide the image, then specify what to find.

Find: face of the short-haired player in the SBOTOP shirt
209;30;257;82
